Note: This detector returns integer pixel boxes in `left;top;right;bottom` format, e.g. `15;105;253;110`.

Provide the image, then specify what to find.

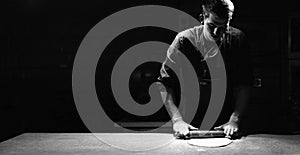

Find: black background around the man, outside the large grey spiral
0;0;300;140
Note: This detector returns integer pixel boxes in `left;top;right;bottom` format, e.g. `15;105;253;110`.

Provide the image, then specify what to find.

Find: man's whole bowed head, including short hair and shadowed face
202;0;234;41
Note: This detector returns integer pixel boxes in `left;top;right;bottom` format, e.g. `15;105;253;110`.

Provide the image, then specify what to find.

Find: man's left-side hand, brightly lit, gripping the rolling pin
173;120;197;137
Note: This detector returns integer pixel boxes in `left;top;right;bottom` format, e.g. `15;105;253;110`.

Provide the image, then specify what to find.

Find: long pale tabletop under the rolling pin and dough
0;133;300;155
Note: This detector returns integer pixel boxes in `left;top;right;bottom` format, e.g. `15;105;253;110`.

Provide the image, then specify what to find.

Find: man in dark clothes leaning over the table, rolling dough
159;0;252;137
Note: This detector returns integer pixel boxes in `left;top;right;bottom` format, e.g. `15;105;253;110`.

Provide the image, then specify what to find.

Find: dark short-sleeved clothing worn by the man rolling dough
160;25;252;127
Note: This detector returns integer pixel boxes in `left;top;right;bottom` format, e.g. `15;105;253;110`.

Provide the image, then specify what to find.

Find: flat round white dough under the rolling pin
187;138;232;147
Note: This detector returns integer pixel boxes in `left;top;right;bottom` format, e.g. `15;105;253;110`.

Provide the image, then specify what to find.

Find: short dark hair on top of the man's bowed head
202;0;234;19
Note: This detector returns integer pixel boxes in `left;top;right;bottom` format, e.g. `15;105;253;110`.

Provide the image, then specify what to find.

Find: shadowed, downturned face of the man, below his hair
204;13;228;41
